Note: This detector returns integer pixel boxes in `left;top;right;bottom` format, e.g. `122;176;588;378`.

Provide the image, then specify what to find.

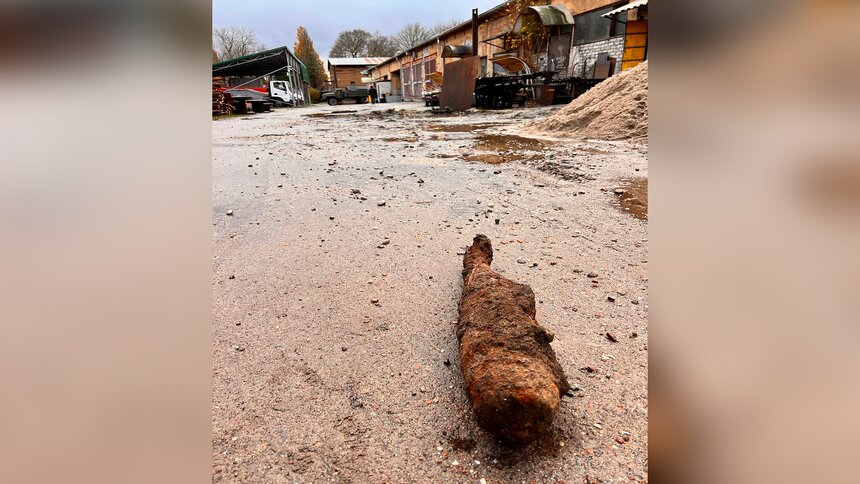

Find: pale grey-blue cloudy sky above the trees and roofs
212;0;502;60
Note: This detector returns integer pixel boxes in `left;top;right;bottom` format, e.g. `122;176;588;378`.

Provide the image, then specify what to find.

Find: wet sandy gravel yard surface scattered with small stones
212;103;648;483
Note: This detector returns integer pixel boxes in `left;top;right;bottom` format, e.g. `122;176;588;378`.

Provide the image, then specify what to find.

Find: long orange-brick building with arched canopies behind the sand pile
366;0;648;99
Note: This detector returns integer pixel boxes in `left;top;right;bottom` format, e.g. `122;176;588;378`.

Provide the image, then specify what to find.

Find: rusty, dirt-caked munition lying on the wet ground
457;235;570;445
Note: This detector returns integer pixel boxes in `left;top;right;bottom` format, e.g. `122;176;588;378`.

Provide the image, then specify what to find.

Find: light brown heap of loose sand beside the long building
525;61;648;144
